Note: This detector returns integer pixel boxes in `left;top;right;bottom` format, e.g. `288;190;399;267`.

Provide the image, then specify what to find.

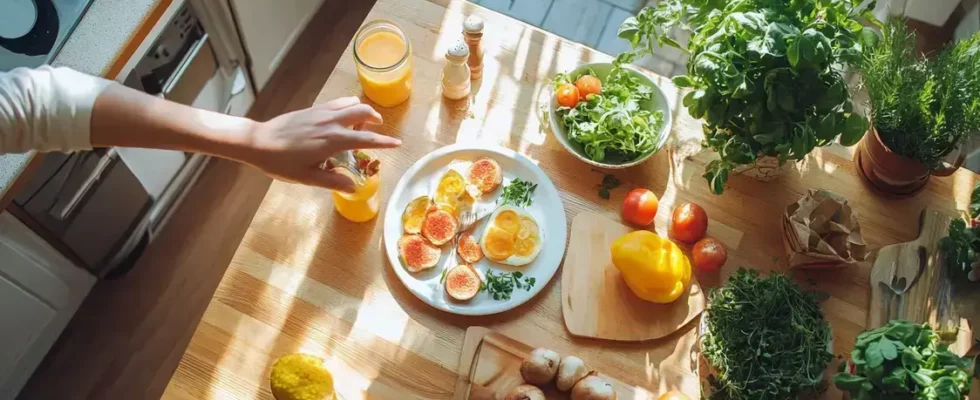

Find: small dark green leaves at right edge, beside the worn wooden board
939;183;980;280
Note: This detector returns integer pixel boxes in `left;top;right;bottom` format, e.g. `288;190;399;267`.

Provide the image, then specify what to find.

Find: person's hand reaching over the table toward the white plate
242;97;401;192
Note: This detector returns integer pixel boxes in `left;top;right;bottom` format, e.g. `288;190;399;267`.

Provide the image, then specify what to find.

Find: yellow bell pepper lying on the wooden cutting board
612;231;691;304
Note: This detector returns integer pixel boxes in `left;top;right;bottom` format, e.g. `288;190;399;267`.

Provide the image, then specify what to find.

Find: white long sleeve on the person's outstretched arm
0;66;112;154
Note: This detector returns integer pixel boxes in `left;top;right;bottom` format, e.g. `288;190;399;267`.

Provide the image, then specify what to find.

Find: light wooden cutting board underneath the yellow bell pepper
561;212;707;341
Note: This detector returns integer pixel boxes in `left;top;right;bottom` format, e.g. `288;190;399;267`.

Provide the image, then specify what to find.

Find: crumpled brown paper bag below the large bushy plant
782;189;867;268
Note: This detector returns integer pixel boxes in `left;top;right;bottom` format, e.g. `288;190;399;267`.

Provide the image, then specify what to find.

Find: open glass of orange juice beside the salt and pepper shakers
354;20;412;107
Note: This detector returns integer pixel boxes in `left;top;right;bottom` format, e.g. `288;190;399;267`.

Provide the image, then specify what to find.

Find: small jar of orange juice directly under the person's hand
333;150;381;222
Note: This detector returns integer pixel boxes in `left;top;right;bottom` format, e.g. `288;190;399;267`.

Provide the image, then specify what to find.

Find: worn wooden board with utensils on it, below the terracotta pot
865;208;980;354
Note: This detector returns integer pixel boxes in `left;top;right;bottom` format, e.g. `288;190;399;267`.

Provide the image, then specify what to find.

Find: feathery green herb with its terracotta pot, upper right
857;20;980;195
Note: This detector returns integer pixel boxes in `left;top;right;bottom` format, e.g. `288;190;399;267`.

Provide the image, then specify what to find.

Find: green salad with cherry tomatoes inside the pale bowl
552;54;664;163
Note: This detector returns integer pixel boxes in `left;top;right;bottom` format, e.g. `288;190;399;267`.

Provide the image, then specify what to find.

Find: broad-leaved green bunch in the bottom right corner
834;320;972;400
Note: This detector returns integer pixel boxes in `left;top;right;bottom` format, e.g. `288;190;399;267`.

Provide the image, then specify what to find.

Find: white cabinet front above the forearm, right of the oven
230;0;323;90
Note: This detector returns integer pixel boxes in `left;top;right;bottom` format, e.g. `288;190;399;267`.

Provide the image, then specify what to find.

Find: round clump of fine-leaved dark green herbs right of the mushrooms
699;269;833;400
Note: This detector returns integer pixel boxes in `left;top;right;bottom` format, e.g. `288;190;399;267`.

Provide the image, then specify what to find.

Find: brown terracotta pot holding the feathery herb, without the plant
854;127;965;196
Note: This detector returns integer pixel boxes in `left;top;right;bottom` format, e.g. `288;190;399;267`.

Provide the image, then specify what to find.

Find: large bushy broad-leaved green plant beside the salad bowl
619;0;878;194
